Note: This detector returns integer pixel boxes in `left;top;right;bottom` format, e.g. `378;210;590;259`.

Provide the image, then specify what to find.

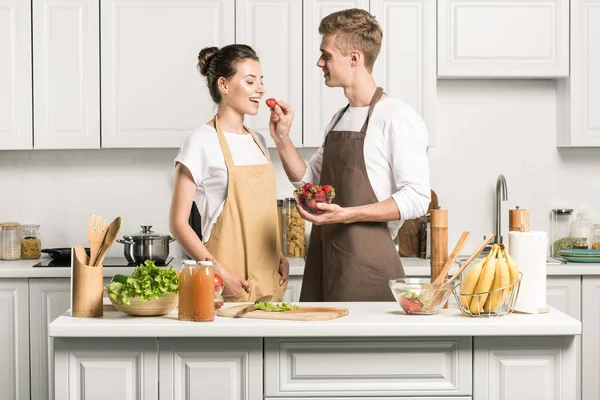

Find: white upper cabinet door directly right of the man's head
371;0;437;146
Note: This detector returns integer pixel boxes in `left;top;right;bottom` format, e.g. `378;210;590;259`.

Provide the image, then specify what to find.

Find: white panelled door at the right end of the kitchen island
473;336;577;400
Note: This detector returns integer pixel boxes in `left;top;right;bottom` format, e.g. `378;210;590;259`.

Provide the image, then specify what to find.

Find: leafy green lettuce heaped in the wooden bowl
106;260;179;305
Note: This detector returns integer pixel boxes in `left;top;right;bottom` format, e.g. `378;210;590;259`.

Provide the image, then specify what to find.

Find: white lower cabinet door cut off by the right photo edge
581;276;600;400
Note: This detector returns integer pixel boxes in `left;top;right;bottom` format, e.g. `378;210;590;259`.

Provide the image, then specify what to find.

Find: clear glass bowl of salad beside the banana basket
390;278;456;315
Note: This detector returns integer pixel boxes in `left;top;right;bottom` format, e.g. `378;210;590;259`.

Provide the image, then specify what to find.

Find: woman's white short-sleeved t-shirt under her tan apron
175;124;268;243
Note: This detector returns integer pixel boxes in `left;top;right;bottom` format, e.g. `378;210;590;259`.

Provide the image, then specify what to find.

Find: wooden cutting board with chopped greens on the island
217;304;348;321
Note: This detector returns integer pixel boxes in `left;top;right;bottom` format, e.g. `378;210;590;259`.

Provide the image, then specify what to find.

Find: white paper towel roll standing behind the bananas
508;231;548;314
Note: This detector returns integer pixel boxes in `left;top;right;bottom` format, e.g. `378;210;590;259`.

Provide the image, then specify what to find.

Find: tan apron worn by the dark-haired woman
206;116;287;302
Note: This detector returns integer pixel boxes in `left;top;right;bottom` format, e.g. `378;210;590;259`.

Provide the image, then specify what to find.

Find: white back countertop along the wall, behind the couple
0;257;600;279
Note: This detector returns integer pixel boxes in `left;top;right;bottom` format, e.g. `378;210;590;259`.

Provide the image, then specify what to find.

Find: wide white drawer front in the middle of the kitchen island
264;337;472;398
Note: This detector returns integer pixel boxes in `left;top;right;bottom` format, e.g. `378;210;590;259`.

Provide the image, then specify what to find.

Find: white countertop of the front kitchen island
48;302;581;337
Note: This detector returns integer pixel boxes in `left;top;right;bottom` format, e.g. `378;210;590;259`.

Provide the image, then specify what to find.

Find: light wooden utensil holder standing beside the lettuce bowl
71;246;104;318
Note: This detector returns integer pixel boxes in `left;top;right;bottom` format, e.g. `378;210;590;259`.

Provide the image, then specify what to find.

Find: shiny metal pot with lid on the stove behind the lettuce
117;225;175;264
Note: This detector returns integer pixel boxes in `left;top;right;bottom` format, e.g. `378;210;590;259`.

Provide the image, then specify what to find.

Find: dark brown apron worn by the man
300;88;405;301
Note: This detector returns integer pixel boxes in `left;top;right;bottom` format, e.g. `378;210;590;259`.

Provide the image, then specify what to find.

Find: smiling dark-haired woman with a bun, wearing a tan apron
169;44;289;302
